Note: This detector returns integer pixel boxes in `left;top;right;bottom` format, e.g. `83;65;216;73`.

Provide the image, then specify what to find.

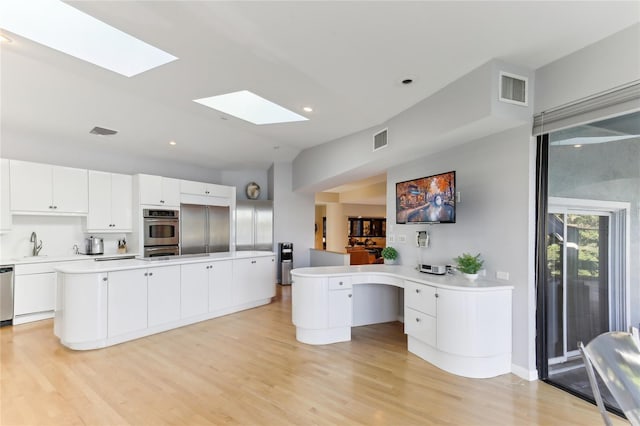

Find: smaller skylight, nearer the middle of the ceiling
194;90;308;125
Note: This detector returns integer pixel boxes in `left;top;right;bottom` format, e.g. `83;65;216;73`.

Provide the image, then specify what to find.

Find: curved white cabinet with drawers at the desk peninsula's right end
405;281;511;378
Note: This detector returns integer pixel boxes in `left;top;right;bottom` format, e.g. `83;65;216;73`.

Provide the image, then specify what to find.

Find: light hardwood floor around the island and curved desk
0;286;628;426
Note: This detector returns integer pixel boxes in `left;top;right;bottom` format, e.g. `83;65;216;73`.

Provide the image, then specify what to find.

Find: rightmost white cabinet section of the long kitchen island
233;256;276;305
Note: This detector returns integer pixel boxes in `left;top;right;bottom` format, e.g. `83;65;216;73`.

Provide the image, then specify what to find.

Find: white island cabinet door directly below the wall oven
146;265;181;327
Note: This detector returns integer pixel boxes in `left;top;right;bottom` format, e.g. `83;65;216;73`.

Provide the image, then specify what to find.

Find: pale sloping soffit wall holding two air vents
293;60;534;192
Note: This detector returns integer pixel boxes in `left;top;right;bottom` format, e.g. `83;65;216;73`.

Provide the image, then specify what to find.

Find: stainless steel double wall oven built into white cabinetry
142;209;180;257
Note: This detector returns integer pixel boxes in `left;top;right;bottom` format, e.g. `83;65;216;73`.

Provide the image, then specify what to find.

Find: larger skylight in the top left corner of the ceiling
0;0;178;77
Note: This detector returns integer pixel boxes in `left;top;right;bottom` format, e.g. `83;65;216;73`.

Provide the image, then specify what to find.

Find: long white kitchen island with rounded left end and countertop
54;251;276;350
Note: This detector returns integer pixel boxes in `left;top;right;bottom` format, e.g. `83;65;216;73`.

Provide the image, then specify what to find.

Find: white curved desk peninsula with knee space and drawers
291;265;513;378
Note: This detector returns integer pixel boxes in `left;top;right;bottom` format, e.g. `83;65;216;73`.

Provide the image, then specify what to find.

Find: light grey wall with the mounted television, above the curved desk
387;126;535;376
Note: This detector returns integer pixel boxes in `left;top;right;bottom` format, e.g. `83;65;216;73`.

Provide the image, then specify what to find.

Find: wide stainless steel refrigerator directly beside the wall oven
180;204;230;254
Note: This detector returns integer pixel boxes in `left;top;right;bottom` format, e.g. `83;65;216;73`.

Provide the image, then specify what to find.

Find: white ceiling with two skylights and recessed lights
0;1;640;176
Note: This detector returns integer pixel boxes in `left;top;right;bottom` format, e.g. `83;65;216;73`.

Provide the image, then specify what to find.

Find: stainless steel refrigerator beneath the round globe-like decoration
236;200;273;251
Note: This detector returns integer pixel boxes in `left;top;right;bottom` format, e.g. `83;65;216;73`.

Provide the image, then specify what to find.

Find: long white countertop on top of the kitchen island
54;251;274;274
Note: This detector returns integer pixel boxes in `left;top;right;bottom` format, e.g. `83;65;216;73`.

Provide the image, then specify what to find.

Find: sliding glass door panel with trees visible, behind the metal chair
546;210;611;370
